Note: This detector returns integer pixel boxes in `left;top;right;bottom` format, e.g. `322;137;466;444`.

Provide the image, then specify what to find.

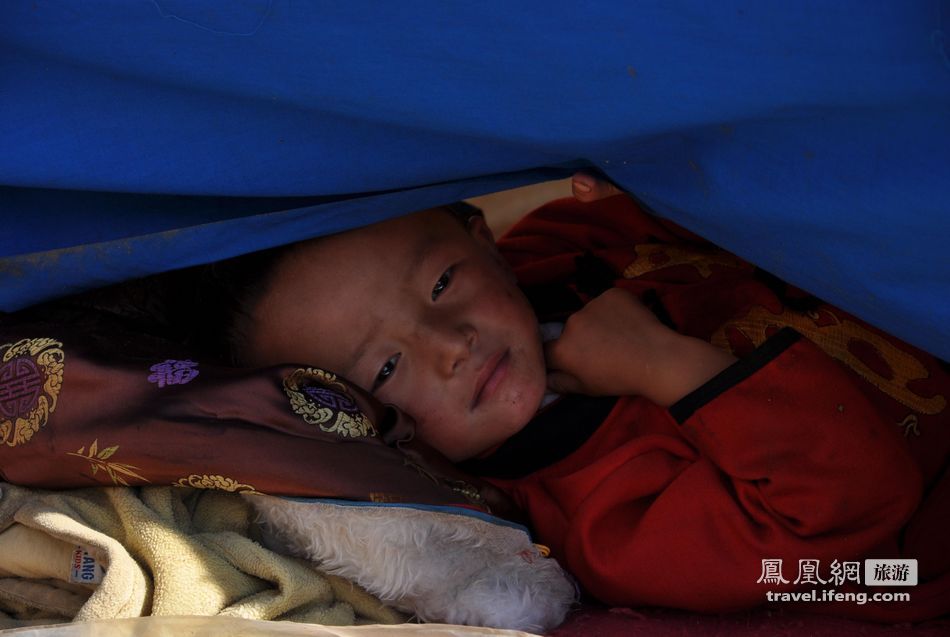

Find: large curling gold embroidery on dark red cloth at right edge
711;305;947;415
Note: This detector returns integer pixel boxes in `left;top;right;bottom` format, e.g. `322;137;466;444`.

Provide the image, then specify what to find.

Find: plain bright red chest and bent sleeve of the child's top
502;332;921;611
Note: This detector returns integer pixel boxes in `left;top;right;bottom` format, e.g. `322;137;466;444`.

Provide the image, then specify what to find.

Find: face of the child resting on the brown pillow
249;210;545;460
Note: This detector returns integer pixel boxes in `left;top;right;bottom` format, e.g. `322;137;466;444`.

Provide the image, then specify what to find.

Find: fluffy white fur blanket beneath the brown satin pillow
245;495;577;632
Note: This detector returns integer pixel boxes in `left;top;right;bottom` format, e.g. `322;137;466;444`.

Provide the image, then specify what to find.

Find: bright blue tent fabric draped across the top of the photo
0;0;950;359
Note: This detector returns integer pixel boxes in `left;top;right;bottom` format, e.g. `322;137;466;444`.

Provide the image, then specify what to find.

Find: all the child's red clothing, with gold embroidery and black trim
488;196;950;621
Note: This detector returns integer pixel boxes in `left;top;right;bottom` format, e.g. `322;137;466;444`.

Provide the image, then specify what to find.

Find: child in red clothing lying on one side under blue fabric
227;175;950;620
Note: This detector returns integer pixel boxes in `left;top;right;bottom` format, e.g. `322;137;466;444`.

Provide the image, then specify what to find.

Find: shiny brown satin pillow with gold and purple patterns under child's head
0;310;505;514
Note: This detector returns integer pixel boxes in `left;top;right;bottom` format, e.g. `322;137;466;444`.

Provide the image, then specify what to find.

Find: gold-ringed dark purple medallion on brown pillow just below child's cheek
284;367;376;438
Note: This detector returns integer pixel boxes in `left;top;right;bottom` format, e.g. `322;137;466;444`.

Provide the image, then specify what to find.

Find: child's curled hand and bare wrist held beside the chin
545;289;735;406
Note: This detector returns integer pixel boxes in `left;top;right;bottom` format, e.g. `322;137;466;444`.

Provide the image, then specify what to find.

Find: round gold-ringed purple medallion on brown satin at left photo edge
0;338;66;447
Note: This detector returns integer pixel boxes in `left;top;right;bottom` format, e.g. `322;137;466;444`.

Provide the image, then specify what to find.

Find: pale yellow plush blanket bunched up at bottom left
0;484;403;628
